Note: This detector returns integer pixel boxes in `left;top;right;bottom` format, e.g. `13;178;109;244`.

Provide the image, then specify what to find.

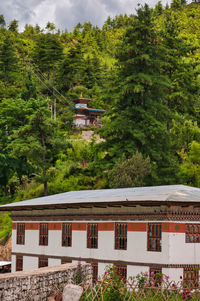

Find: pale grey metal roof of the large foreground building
0;185;200;211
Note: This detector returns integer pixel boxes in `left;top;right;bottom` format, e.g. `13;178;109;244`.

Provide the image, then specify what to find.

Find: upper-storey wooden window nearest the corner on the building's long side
147;224;162;252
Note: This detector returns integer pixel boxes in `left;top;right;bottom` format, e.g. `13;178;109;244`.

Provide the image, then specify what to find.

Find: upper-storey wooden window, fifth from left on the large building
115;223;127;250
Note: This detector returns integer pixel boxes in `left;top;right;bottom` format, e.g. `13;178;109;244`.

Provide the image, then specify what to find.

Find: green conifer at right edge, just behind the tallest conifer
162;12;199;119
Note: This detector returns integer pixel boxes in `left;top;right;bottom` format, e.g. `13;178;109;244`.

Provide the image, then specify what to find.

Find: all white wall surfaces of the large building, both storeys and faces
12;221;200;278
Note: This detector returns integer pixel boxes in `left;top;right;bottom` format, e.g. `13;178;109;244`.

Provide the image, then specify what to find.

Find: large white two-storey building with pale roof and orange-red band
0;185;200;281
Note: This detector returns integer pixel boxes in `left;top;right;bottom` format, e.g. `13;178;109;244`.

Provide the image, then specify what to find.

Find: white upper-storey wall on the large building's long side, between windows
13;219;169;264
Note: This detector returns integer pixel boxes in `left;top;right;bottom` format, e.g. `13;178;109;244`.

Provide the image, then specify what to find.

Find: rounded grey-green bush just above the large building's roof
108;152;150;188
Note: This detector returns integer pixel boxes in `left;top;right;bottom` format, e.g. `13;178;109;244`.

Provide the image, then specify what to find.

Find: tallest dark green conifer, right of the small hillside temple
102;5;174;182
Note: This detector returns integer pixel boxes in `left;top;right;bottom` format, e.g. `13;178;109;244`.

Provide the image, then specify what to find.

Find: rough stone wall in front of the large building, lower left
0;263;92;301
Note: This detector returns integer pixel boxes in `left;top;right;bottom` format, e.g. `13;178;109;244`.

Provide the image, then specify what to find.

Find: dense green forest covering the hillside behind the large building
0;0;200;239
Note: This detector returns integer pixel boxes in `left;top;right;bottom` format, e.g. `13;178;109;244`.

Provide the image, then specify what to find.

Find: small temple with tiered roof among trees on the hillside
71;96;105;128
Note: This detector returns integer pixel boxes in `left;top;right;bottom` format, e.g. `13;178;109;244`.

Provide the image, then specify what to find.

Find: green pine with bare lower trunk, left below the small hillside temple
9;100;66;195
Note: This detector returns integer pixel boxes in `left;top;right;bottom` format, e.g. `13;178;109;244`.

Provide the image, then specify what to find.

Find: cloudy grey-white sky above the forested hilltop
0;0;170;31
